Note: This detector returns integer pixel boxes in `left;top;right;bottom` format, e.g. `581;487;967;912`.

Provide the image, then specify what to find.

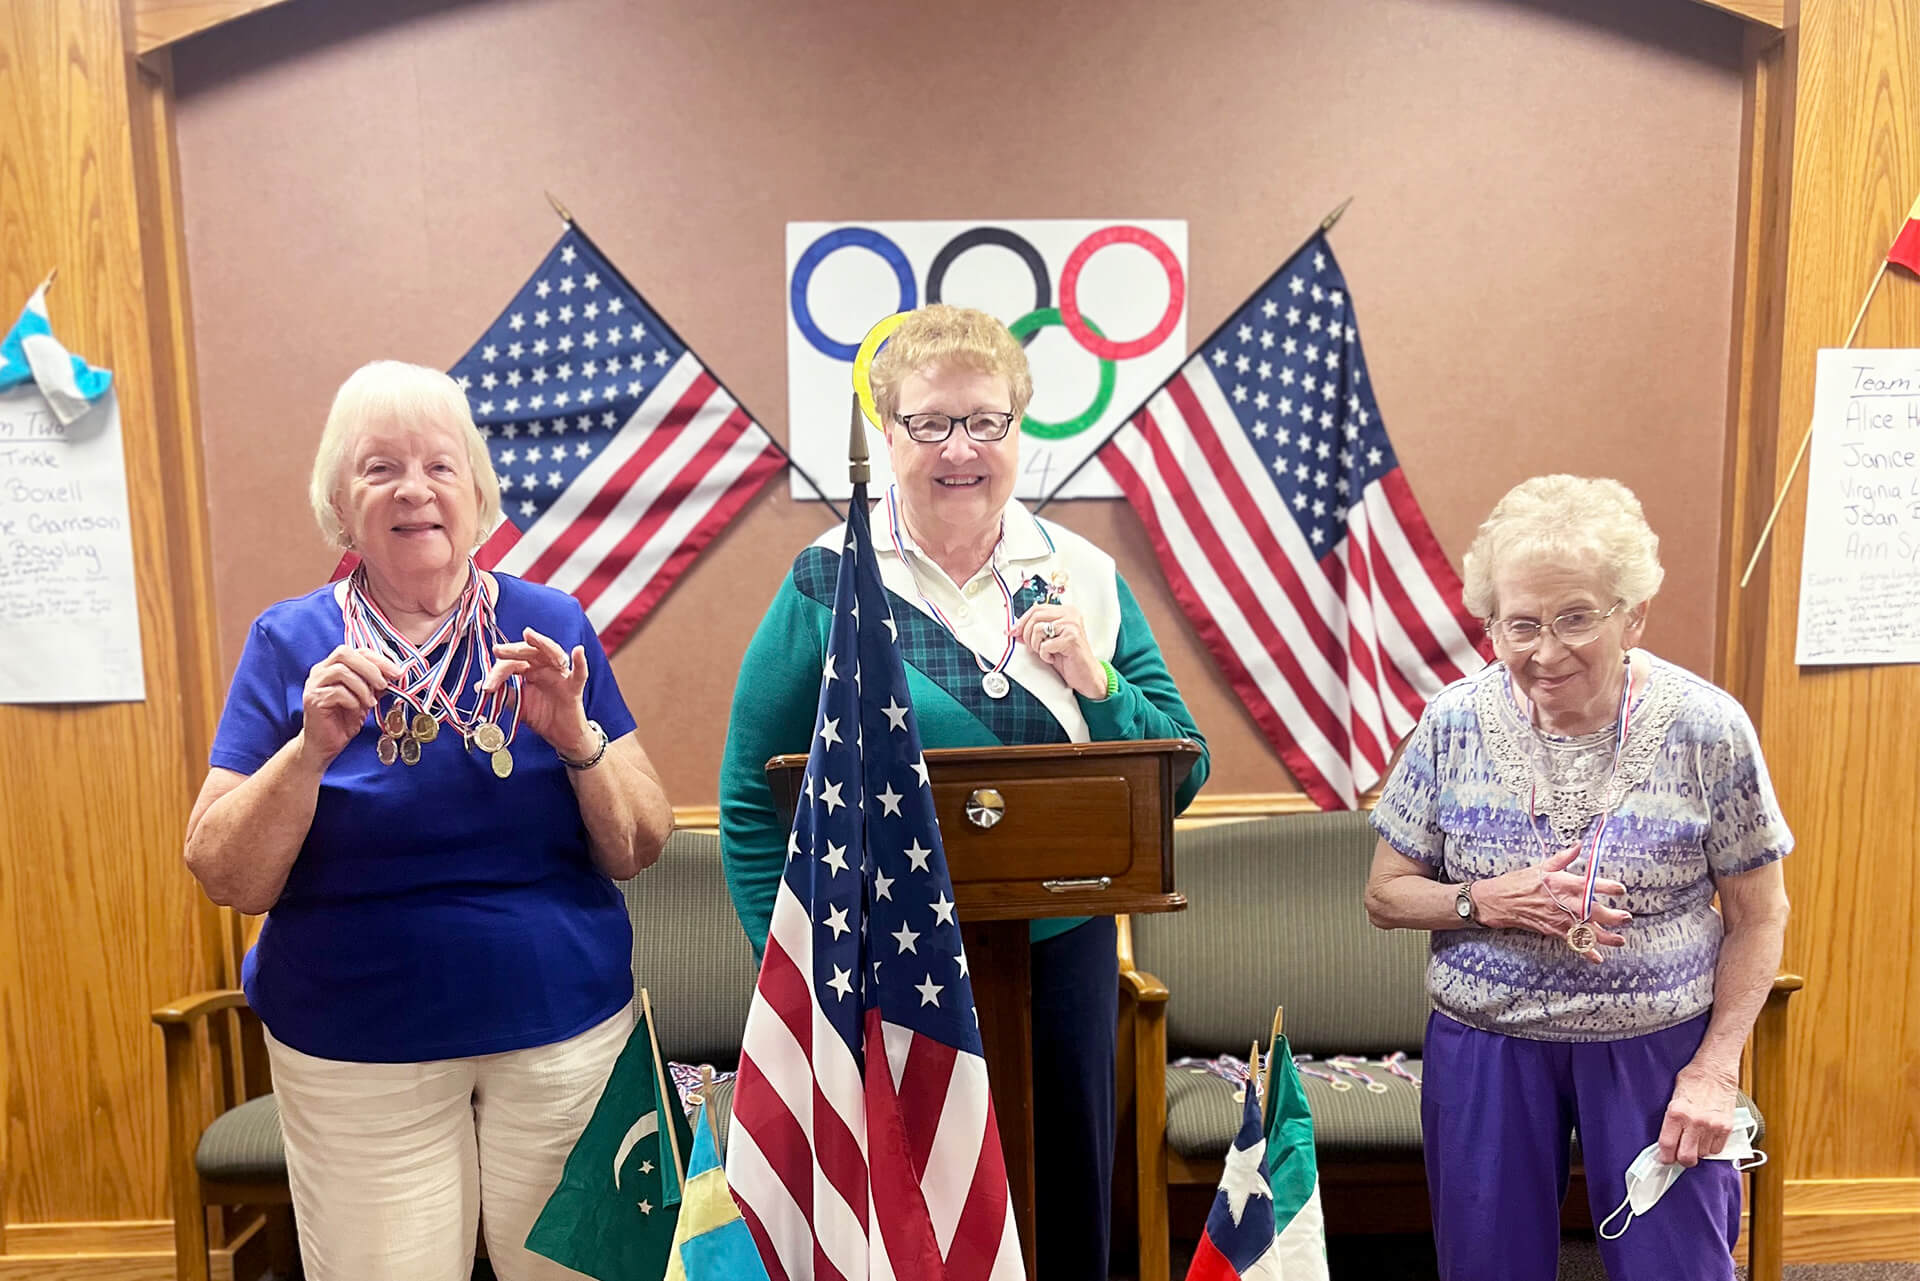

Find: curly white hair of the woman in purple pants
1461;474;1667;618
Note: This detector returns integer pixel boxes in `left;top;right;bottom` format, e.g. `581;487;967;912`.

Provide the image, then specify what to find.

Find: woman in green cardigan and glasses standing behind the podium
720;303;1208;1281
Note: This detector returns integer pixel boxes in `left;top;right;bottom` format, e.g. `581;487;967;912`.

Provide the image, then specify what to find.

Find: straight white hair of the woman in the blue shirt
307;361;499;547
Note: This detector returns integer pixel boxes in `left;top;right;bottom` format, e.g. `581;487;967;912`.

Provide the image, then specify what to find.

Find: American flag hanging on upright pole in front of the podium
726;486;1025;1281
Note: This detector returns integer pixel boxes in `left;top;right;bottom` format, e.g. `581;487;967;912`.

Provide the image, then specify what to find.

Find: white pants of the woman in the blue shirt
267;1006;634;1281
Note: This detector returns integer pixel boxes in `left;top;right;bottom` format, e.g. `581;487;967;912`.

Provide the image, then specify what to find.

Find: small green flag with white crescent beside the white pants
526;1003;693;1281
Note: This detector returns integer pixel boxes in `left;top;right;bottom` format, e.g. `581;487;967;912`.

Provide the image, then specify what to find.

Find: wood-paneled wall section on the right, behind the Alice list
1720;0;1920;1258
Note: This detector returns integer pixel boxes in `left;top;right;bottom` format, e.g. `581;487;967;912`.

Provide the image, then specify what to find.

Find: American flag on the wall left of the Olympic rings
449;225;785;651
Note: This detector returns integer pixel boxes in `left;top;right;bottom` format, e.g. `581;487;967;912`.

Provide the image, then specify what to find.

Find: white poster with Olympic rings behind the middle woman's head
787;219;1187;499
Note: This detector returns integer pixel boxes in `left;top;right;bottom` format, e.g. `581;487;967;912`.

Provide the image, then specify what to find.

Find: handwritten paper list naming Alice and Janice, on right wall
1795;348;1920;665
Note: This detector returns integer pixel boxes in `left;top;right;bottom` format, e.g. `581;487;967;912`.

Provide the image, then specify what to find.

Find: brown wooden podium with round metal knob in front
766;739;1200;1277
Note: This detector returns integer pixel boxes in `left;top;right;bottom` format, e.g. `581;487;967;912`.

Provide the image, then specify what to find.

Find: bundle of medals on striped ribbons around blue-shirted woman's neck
342;561;520;778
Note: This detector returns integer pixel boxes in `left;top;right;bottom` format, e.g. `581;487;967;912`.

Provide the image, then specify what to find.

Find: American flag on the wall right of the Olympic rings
1098;234;1488;809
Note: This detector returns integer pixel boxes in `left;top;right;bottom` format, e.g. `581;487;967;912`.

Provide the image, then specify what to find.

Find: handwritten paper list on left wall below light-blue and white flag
0;384;146;703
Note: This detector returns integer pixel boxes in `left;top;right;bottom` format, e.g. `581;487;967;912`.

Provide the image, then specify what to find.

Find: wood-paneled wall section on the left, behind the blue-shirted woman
0;0;234;1277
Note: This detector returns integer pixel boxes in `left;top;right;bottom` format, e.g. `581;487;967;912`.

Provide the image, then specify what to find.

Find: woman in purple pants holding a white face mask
1367;476;1793;1281
